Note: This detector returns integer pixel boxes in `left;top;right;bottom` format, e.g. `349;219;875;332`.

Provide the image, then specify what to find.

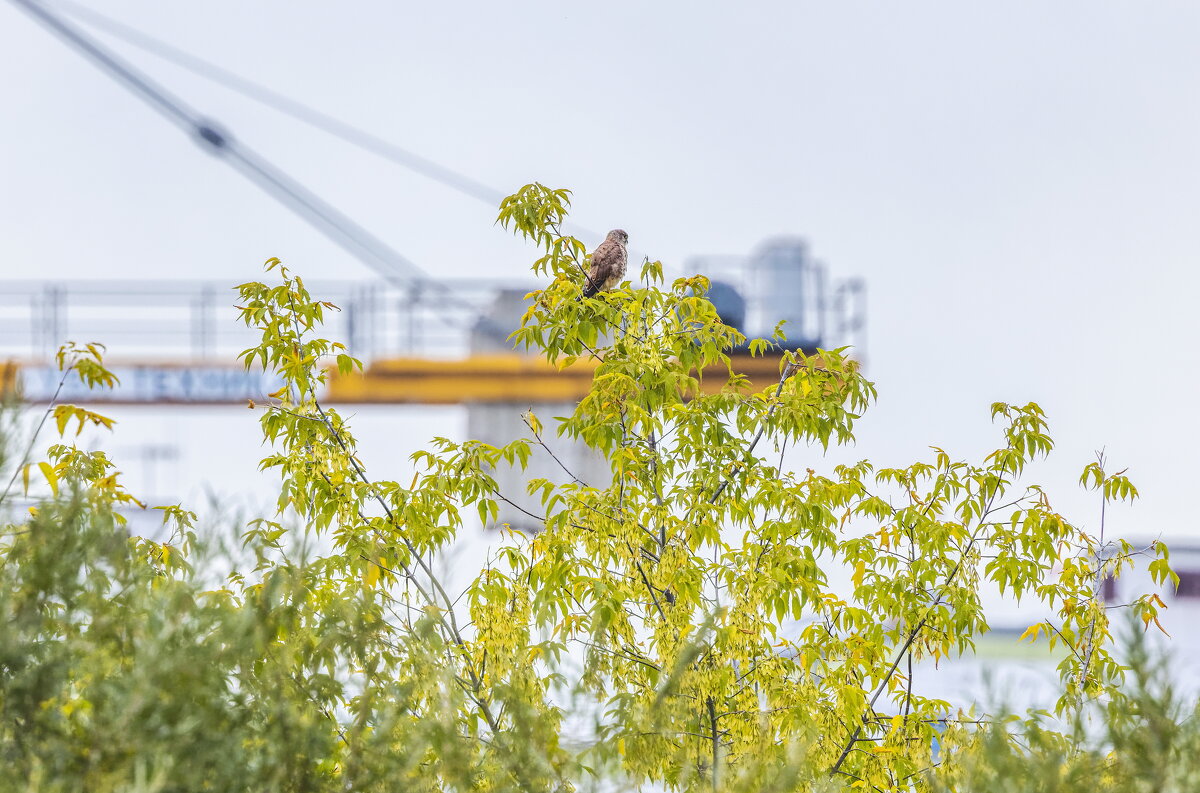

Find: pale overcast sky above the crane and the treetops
0;0;1200;539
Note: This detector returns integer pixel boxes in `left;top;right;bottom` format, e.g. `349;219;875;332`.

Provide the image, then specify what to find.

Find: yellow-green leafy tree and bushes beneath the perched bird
0;185;1174;791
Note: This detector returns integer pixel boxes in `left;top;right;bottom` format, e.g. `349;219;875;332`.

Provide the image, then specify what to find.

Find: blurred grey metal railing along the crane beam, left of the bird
0;280;532;361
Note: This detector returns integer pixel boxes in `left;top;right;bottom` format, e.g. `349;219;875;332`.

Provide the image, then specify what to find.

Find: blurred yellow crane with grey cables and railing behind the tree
0;0;865;404
